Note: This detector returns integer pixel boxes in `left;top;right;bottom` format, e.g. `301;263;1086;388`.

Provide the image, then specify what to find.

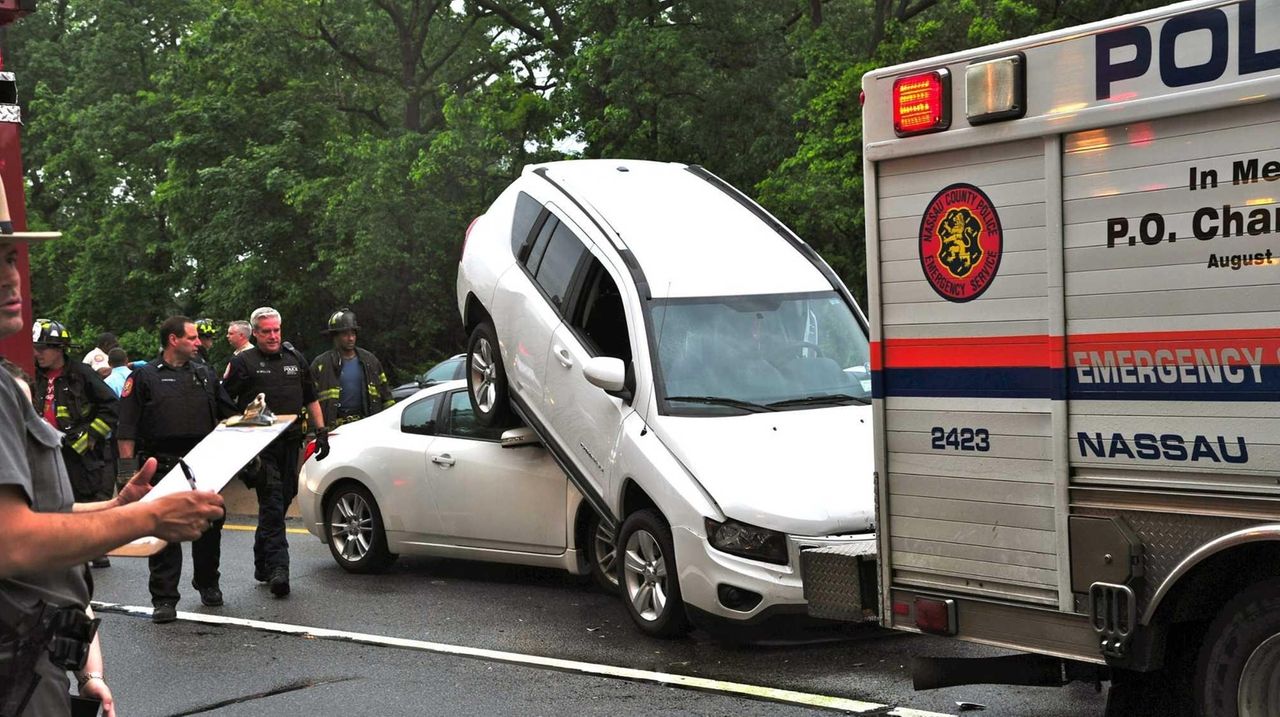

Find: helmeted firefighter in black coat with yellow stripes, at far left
31;319;116;567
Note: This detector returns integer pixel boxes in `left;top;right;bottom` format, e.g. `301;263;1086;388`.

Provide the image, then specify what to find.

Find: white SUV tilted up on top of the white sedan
458;160;876;636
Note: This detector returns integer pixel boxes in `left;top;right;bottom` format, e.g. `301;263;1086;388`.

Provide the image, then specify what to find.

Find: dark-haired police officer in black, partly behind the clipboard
115;316;236;622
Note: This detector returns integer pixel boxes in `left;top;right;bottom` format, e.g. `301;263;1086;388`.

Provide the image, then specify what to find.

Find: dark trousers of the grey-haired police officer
253;434;302;574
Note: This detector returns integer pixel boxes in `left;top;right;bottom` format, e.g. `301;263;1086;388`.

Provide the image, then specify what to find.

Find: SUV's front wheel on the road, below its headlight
618;510;689;638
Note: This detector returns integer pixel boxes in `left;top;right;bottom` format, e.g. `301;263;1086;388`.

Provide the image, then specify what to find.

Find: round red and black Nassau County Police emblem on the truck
920;184;1005;302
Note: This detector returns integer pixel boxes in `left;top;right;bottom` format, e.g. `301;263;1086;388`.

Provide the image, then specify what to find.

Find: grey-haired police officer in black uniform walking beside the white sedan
224;306;329;598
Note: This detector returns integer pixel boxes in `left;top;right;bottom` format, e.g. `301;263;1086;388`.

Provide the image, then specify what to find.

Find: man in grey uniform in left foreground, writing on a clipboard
0;233;223;717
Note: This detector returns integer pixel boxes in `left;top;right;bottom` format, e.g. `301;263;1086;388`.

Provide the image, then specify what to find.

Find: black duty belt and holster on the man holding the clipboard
0;600;99;717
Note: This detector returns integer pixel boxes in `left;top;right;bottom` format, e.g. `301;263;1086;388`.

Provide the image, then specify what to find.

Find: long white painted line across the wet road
93;600;945;717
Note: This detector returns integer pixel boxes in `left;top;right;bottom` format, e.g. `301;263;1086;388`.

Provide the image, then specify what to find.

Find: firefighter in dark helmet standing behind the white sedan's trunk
311;309;396;428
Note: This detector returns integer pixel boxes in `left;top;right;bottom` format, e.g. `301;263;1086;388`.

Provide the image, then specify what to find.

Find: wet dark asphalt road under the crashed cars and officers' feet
87;516;1103;717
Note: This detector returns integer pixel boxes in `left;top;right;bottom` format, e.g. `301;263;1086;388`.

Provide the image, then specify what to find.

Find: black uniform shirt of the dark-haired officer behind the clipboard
115;359;236;453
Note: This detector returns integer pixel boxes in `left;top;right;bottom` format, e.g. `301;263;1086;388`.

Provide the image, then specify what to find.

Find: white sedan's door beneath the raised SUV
428;391;568;554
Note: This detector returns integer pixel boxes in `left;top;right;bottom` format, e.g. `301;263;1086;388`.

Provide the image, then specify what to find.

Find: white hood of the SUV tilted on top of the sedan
652;406;876;535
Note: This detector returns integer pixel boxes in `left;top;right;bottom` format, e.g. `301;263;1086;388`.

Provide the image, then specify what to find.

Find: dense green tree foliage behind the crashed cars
5;0;1172;373
